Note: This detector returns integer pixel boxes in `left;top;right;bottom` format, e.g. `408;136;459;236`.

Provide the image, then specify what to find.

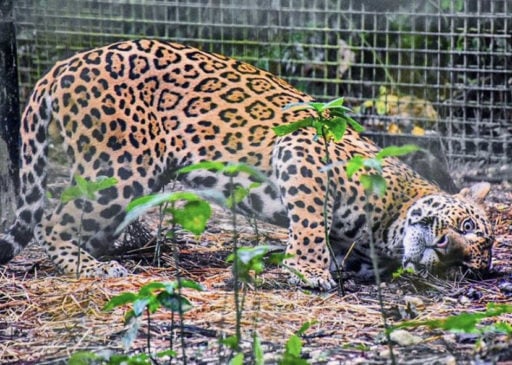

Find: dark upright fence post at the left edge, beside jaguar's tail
0;0;20;231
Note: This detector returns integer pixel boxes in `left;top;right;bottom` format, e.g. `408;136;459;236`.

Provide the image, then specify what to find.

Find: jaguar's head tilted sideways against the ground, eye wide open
402;183;494;274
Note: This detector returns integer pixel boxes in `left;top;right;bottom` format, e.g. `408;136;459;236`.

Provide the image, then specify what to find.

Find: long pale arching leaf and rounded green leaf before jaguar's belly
116;191;212;235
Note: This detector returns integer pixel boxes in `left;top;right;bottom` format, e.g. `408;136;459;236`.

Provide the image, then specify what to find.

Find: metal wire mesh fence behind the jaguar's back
15;0;512;162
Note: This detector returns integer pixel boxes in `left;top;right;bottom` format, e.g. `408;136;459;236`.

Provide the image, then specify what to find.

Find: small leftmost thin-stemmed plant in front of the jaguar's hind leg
60;175;117;279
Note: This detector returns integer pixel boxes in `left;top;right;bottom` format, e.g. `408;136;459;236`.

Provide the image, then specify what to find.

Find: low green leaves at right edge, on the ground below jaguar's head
388;303;512;336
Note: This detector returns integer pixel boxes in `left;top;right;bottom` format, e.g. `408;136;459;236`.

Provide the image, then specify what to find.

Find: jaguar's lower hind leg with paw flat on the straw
35;186;128;277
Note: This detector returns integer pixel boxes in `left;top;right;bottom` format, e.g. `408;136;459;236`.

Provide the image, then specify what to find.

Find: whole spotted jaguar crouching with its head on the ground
0;39;493;290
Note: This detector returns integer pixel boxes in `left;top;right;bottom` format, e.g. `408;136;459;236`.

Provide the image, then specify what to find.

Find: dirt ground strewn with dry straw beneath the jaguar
0;178;512;364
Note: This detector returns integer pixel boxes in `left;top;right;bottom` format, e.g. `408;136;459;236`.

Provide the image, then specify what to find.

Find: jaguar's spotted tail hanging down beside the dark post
0;78;52;264
